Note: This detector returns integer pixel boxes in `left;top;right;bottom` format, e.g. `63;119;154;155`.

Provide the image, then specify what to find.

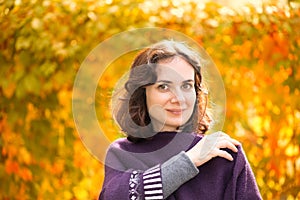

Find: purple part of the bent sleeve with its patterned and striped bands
99;144;163;200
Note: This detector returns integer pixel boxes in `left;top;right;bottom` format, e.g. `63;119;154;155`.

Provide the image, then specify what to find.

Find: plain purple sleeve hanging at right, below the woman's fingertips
225;146;262;200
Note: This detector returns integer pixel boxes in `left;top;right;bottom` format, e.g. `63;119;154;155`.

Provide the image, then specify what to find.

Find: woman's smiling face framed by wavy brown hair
146;57;196;131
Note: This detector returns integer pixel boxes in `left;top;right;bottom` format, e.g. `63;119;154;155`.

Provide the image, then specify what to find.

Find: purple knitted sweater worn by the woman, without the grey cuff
99;132;261;200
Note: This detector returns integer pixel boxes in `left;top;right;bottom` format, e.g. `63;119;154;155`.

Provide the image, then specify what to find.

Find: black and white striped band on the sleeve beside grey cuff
143;165;163;200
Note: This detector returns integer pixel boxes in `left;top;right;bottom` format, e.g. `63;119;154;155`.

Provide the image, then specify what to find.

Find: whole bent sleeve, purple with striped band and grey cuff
99;144;199;200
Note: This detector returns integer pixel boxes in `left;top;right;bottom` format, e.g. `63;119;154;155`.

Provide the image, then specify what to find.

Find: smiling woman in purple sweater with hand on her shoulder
99;41;261;200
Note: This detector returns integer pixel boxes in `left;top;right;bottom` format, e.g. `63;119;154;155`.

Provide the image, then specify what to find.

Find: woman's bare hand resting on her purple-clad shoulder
186;131;240;167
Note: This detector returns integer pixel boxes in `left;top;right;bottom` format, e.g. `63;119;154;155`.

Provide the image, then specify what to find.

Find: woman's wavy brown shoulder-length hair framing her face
113;41;211;141
